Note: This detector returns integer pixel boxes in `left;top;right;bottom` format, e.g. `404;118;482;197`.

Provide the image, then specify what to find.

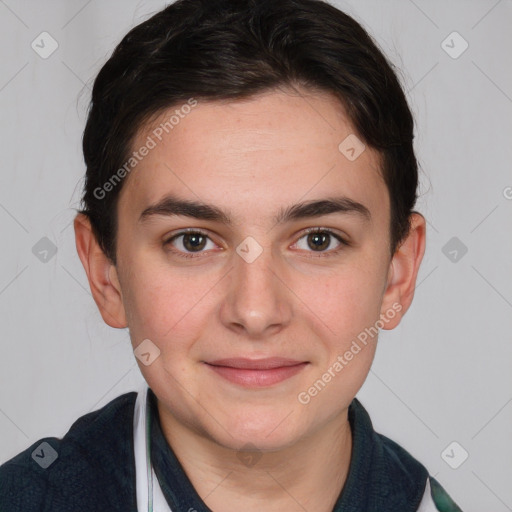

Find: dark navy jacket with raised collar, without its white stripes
0;390;460;512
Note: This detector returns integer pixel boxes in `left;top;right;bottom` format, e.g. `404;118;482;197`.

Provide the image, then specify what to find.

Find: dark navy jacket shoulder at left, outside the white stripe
0;392;137;512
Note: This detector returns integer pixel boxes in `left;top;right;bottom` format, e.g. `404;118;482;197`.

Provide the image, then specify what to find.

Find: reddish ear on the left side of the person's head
74;213;127;329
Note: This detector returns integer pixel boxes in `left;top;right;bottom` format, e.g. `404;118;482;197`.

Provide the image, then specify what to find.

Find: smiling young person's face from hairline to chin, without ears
116;92;397;449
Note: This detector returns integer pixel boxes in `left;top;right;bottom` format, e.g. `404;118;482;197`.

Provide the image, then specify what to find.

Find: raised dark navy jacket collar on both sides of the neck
148;389;428;512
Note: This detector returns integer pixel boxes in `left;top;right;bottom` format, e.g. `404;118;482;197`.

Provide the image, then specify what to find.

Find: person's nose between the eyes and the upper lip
220;241;293;339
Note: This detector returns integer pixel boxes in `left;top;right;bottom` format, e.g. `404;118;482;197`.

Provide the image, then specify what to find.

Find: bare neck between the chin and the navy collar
158;402;352;512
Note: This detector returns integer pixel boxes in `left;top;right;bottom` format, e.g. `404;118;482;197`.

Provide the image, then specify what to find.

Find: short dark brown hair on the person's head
79;0;418;264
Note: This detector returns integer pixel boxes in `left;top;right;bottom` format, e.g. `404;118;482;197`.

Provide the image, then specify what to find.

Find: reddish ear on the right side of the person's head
380;212;426;330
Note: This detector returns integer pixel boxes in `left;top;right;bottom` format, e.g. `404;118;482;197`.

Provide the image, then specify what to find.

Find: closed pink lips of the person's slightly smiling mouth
206;357;308;387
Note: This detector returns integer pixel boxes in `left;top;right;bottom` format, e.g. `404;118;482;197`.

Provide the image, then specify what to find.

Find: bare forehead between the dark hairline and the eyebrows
120;91;389;226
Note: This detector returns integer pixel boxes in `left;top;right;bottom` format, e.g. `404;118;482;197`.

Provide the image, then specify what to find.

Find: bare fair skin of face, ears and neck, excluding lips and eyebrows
75;90;425;512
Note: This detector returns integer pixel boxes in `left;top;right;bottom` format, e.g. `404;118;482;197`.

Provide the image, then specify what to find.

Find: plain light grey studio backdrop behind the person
0;0;512;512
